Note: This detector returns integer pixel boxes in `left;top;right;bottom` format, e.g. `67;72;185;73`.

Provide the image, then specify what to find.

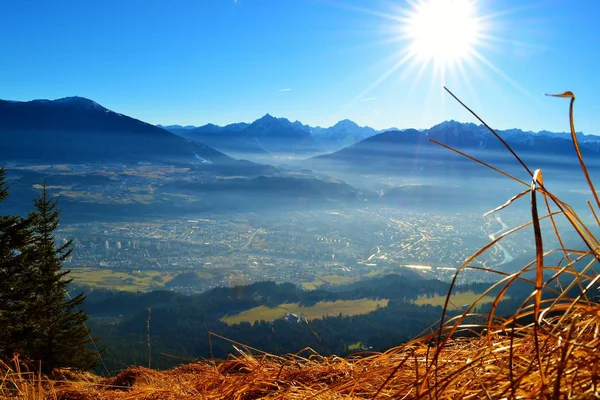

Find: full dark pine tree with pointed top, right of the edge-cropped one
26;183;96;372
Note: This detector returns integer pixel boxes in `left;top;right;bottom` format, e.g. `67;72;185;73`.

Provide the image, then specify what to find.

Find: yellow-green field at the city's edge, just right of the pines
69;267;176;292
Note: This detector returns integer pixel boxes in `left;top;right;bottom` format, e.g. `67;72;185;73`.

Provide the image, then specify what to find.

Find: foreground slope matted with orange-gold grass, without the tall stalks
0;304;600;400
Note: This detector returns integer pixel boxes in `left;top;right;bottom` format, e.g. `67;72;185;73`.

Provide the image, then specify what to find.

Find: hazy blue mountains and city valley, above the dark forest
0;97;600;293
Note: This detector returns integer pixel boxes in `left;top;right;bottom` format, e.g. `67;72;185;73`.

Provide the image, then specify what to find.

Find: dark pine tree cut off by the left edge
0;168;35;359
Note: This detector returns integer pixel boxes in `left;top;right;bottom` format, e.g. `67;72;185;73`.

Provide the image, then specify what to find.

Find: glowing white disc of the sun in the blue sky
401;0;482;66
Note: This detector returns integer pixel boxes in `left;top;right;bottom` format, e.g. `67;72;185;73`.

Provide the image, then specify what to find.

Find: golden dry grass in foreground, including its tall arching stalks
0;92;600;400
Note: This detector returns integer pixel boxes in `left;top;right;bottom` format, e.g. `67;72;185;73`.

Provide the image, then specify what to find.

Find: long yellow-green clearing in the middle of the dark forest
221;299;389;325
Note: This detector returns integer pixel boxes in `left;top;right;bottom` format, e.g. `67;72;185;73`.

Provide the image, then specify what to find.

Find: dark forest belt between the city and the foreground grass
84;271;530;373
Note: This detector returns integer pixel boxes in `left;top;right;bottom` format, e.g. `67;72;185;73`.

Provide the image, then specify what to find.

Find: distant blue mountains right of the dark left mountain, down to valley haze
159;114;600;185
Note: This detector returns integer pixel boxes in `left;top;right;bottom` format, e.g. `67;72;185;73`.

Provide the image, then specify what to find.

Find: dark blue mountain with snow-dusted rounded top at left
0;97;232;163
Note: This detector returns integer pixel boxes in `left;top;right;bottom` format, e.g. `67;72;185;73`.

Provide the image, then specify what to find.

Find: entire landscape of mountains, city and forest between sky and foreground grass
0;94;600;376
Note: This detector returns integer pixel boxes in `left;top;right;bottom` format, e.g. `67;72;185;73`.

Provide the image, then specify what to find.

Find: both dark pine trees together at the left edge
0;168;97;373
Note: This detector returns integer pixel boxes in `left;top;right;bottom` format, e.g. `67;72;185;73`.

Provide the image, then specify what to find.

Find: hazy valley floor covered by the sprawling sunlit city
58;208;532;293
